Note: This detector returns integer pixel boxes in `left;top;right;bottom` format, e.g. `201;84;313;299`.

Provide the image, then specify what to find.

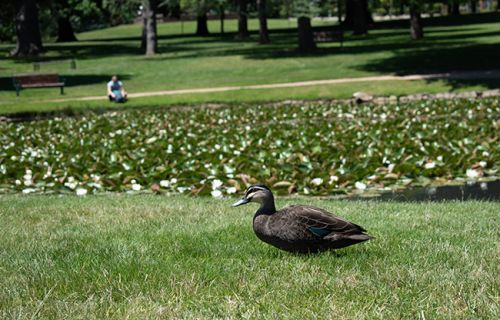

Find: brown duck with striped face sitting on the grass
233;184;373;253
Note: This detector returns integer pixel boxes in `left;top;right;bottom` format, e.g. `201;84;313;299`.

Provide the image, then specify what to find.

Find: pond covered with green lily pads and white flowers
0;99;500;197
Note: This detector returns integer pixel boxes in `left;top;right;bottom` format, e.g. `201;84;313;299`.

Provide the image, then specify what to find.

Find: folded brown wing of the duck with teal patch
284;205;366;238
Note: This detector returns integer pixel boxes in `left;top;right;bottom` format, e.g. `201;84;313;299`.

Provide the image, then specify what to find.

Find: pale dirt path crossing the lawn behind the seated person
50;70;500;102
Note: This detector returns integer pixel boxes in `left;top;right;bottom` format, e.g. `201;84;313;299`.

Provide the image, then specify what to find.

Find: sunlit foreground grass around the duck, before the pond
0;196;500;319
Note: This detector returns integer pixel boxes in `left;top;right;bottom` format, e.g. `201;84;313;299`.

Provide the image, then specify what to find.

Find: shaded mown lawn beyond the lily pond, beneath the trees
0;17;500;113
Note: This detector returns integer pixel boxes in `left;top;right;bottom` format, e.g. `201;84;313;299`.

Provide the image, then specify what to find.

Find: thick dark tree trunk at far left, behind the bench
10;0;43;56
